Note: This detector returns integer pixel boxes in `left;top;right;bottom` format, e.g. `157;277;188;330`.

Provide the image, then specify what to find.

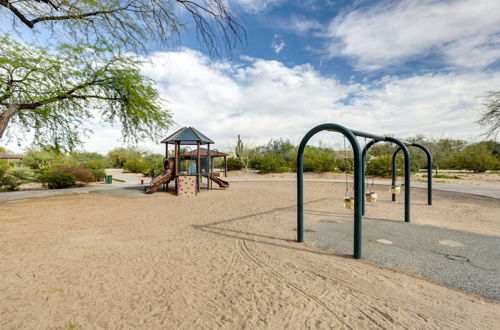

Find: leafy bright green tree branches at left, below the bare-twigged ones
0;36;172;149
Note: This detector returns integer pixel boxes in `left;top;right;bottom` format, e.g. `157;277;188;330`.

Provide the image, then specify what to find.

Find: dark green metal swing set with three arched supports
297;123;432;259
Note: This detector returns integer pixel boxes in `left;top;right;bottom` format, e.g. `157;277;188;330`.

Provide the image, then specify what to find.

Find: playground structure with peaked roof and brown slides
146;127;229;196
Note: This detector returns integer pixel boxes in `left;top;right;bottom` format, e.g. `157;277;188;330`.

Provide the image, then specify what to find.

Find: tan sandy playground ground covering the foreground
0;182;500;329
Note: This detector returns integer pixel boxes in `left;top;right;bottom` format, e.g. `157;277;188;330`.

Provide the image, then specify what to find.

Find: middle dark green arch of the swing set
361;136;411;222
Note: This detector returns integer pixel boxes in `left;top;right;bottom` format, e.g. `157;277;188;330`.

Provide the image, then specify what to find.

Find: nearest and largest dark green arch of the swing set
297;123;363;259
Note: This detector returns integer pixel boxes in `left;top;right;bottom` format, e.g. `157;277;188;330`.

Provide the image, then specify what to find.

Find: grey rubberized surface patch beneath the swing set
305;214;500;301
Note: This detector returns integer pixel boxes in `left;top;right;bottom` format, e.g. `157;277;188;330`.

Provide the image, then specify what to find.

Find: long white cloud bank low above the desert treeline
3;49;500;152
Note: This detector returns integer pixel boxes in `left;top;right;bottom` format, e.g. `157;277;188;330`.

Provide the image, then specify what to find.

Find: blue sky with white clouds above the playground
1;0;500;152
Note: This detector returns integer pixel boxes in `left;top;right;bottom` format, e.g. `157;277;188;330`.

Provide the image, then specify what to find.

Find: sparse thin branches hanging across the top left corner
0;0;245;55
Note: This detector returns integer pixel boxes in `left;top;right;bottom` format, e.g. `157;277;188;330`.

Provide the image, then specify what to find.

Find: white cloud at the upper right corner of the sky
326;0;500;70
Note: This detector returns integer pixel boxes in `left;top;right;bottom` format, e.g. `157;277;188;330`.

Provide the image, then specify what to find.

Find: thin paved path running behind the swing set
227;178;500;199
